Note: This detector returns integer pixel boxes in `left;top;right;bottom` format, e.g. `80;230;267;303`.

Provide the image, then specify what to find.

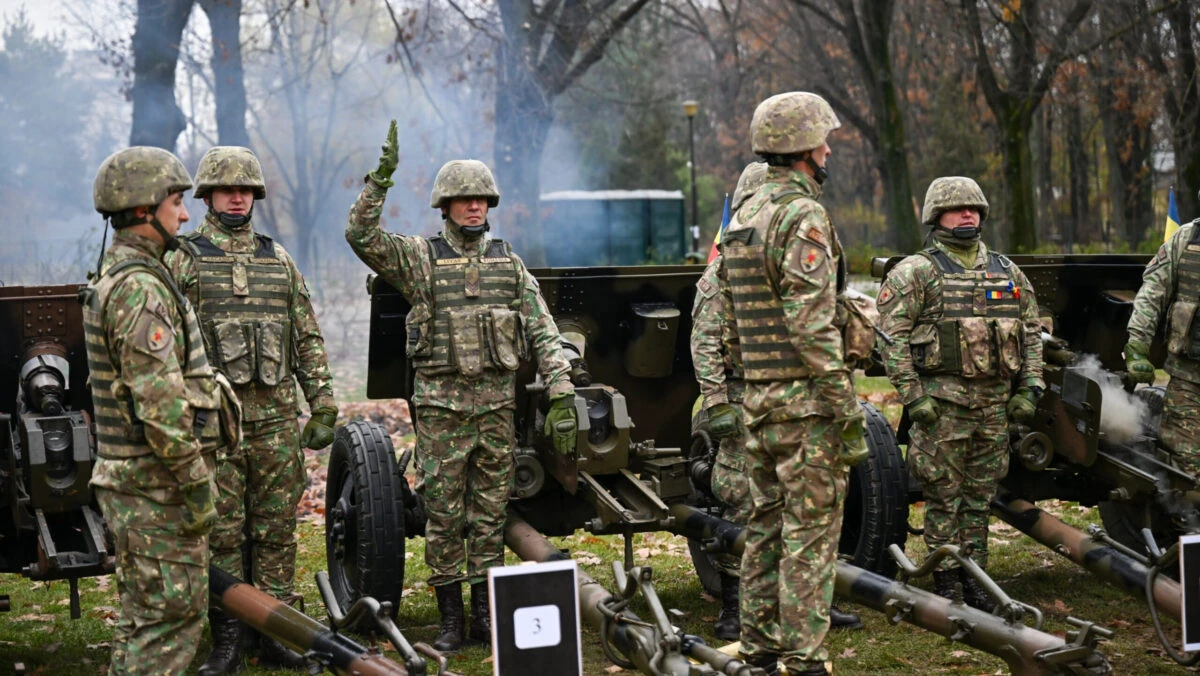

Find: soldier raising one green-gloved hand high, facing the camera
346;120;576;651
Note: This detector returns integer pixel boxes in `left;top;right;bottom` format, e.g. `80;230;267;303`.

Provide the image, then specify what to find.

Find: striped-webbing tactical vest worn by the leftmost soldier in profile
80;258;221;459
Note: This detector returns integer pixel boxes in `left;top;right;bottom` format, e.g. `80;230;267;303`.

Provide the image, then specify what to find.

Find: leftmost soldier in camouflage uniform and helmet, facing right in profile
80;146;236;675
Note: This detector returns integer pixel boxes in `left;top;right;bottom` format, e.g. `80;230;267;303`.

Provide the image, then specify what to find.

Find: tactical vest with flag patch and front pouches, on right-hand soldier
908;247;1025;378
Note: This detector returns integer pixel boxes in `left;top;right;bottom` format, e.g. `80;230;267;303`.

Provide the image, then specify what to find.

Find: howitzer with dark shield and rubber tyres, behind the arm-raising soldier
326;265;1109;675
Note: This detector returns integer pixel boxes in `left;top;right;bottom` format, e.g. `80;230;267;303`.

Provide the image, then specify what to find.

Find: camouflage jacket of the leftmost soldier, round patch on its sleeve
89;231;209;504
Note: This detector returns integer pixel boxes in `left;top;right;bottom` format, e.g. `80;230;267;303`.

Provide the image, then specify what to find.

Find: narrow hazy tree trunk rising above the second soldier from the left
200;0;250;148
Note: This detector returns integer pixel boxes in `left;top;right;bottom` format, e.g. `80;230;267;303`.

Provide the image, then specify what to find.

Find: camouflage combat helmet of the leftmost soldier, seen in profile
91;145;192;214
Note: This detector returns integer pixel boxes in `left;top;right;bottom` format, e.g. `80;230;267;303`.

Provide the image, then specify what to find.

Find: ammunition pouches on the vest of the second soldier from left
208;319;292;387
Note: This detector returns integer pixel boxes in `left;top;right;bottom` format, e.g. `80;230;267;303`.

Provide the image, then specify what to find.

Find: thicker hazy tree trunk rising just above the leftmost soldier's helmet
130;0;192;150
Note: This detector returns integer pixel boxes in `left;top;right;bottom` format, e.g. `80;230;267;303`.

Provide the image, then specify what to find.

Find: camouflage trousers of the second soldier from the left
209;418;308;599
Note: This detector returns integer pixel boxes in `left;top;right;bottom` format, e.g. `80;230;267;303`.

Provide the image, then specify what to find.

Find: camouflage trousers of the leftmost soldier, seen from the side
96;487;209;676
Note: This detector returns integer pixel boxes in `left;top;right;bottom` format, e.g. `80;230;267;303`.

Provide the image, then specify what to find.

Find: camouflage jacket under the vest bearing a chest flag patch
876;241;1045;408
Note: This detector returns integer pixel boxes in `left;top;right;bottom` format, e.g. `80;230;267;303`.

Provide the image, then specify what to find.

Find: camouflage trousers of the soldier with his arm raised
416;406;515;586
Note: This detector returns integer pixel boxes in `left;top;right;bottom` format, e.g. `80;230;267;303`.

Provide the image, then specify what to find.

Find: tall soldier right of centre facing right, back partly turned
720;91;868;676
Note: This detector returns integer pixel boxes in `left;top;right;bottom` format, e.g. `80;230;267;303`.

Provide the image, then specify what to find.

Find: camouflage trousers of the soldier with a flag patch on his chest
908;400;1008;570
